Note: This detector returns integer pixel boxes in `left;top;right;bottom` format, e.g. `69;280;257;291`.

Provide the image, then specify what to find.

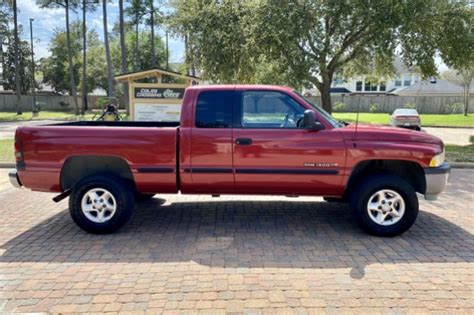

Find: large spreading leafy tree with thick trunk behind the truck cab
173;0;472;111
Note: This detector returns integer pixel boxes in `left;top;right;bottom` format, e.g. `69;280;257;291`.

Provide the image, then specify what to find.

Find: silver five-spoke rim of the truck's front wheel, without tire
367;189;405;226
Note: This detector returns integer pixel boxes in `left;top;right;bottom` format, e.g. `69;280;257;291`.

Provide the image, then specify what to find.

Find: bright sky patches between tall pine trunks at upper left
17;0;184;62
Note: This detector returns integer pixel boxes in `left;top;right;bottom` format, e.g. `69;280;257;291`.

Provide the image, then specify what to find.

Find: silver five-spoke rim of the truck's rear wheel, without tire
81;188;117;223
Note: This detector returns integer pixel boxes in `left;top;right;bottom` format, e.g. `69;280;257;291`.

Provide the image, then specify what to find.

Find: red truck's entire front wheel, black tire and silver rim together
351;175;418;236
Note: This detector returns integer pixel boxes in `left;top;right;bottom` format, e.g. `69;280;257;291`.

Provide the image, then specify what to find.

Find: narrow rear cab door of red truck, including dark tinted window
184;89;235;194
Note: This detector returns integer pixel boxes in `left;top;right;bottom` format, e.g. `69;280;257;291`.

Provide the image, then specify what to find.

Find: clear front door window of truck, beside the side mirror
241;91;304;129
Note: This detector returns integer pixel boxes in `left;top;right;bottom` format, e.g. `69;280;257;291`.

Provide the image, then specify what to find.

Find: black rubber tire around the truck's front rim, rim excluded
350;174;419;236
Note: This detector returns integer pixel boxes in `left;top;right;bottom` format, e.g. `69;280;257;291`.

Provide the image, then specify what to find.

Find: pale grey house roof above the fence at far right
390;79;474;96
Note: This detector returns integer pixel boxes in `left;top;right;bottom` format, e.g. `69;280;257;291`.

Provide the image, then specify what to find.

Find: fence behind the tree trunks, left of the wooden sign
0;94;125;112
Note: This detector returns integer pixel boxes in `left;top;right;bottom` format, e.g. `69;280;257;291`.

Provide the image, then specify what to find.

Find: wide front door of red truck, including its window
233;90;346;196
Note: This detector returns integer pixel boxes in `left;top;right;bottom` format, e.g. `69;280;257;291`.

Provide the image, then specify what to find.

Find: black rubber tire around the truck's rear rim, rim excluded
69;176;134;234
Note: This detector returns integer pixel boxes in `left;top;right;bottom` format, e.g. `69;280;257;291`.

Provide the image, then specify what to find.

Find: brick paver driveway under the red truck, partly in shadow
0;170;474;314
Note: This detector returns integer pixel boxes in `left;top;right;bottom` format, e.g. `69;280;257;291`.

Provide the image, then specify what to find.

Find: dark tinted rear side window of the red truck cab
195;91;234;128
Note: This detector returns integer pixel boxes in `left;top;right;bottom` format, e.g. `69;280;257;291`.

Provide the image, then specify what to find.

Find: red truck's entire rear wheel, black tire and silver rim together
69;176;134;234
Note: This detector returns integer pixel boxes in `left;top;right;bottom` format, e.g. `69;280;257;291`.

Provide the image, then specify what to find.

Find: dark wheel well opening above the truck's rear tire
60;155;135;191
